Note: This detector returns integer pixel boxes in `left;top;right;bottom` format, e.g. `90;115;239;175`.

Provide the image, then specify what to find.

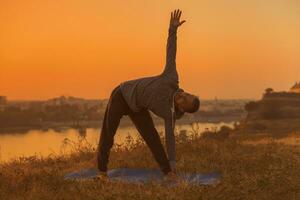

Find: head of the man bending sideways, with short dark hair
174;92;200;113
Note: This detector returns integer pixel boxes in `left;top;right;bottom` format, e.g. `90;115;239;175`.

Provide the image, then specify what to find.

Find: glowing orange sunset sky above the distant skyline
0;0;300;100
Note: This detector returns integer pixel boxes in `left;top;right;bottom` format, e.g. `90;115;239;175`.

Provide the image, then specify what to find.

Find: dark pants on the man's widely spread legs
98;86;171;174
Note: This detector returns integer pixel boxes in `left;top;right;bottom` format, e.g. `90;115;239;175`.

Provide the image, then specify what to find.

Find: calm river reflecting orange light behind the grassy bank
0;123;233;162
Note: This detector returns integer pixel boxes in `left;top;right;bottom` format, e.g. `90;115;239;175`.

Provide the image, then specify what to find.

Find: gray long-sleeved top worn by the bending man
121;26;184;164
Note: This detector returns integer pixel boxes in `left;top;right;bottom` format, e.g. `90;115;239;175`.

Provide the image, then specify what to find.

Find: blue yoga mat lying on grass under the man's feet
65;168;221;185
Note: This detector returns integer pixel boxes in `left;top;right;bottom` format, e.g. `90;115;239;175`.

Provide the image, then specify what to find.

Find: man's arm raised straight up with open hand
163;10;185;74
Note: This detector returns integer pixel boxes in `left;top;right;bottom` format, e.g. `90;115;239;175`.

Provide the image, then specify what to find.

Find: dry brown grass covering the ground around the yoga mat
0;132;300;200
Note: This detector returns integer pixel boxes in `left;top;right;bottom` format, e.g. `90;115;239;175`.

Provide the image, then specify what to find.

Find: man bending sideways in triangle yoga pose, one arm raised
98;10;200;176
